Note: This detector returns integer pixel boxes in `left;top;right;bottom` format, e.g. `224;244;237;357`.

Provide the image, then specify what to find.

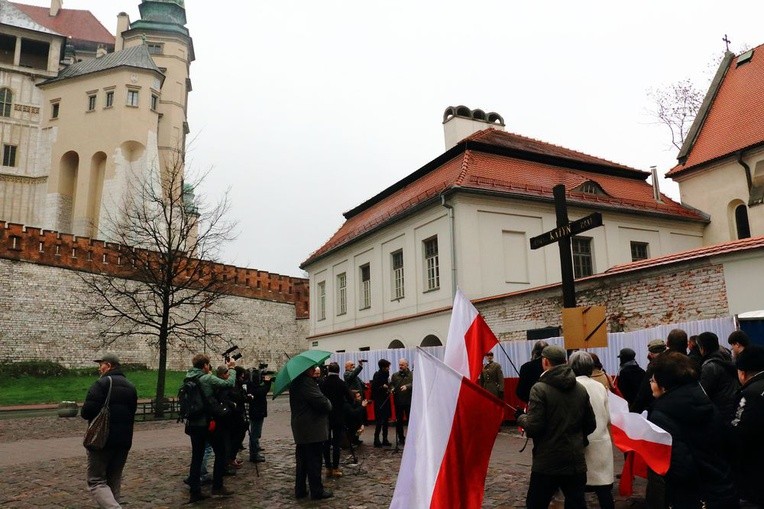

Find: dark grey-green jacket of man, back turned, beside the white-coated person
517;365;597;475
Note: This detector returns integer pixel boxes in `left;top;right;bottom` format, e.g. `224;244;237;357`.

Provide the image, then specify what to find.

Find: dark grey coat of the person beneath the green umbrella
289;373;332;444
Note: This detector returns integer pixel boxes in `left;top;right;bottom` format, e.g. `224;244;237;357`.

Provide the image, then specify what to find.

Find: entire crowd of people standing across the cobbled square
82;329;764;509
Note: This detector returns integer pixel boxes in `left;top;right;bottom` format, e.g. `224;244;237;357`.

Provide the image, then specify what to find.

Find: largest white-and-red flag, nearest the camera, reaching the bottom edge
390;348;505;509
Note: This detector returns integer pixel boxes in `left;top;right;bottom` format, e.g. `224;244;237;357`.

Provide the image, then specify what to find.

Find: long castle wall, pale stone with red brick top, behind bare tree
0;223;308;369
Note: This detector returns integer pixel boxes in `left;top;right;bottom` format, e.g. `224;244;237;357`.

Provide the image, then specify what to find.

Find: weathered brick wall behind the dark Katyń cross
475;259;729;341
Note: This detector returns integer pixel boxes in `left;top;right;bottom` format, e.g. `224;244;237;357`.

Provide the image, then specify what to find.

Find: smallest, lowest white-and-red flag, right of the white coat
608;392;672;496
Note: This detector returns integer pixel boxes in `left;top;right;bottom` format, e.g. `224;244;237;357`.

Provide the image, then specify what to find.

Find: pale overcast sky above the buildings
23;0;764;276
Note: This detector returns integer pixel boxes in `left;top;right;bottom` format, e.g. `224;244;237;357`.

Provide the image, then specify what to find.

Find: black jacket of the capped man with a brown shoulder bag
80;369;138;449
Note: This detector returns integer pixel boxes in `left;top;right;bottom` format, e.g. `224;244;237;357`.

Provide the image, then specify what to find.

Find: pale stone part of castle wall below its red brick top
0;254;308;369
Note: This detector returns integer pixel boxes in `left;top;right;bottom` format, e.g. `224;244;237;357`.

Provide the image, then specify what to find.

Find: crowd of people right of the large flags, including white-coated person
510;329;764;509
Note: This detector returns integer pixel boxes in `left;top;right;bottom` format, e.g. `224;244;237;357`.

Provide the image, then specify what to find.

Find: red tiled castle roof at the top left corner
12;2;116;46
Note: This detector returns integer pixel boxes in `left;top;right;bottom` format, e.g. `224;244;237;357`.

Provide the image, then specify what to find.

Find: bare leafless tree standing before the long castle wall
81;151;235;413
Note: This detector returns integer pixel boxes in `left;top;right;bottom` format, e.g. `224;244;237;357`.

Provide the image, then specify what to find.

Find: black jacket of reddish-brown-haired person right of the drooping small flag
649;383;736;507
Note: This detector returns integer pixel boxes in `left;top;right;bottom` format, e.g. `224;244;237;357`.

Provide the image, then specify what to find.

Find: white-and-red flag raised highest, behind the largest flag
443;288;499;382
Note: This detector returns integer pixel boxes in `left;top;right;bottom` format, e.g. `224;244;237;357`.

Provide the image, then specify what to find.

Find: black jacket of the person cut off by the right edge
731;371;764;507
